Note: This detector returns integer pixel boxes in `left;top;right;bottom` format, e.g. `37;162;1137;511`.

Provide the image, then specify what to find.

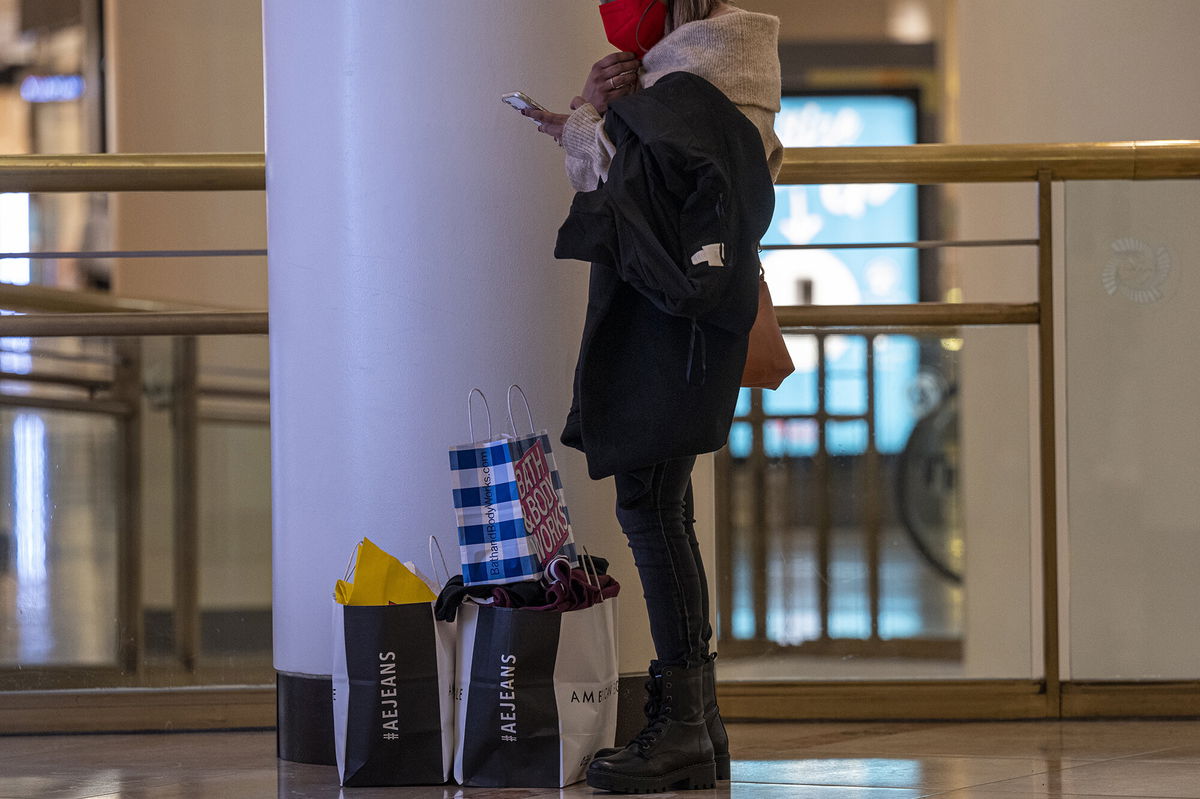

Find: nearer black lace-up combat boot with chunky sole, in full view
588;666;716;793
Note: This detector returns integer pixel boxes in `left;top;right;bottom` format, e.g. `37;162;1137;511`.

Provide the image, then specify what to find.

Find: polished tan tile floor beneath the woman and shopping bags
0;721;1200;799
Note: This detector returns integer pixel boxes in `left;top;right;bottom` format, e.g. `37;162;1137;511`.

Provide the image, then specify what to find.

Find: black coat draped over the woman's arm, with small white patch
554;72;775;480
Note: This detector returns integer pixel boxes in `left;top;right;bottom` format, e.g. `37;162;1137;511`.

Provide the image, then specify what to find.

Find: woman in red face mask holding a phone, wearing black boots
526;0;782;792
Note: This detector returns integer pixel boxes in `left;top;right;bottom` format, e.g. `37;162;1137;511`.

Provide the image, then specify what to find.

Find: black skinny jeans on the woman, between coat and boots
614;456;713;668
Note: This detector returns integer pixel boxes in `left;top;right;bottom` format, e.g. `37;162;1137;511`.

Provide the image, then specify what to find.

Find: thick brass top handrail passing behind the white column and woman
0;139;1200;192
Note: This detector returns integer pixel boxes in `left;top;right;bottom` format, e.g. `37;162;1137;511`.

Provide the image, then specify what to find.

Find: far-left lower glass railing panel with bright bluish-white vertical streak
0;407;118;669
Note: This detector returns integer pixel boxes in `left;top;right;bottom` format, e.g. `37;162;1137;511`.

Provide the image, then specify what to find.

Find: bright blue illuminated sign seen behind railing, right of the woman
730;94;919;457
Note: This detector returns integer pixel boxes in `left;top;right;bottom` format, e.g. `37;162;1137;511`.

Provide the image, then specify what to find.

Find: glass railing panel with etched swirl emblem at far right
1066;180;1200;680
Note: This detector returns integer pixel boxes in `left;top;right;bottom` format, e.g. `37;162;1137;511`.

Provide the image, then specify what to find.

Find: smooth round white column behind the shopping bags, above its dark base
264;0;650;748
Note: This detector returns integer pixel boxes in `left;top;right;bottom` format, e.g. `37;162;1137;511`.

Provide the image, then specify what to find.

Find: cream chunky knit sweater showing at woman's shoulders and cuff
563;8;784;192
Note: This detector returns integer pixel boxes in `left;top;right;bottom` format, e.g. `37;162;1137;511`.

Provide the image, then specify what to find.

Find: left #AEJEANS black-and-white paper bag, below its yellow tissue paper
334;602;455;786
